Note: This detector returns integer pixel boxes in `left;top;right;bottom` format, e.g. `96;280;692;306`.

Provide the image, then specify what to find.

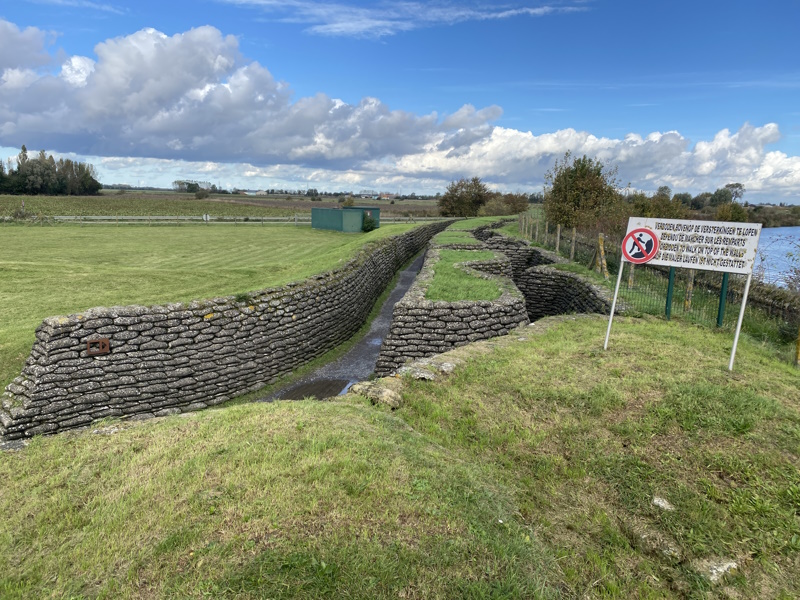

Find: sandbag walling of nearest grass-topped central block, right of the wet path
375;246;528;376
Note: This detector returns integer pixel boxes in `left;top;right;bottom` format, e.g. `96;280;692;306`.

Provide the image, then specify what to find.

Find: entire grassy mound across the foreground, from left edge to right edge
0;317;800;599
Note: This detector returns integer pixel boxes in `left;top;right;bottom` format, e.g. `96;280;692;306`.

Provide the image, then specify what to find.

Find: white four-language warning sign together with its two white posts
603;217;761;371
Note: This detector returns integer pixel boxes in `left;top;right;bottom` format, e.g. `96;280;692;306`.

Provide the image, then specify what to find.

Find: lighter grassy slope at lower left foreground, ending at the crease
0;401;547;598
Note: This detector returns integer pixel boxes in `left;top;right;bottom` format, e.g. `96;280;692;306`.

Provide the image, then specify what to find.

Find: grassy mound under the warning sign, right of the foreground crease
400;318;800;598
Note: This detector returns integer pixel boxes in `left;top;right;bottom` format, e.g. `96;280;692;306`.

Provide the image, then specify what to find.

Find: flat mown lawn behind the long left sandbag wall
0;225;413;387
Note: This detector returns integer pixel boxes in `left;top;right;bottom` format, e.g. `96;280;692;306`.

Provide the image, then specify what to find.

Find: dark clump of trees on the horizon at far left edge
0;145;103;196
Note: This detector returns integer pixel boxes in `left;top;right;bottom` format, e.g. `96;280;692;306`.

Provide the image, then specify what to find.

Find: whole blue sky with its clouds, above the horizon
0;0;800;204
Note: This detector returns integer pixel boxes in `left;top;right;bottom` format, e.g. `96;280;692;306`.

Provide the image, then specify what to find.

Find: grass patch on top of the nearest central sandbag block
425;249;501;302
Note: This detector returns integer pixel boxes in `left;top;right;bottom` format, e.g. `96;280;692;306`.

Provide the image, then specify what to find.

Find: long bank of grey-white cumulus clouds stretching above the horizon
0;20;800;194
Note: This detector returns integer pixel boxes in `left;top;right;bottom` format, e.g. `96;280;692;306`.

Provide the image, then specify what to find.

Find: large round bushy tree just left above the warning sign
544;152;624;233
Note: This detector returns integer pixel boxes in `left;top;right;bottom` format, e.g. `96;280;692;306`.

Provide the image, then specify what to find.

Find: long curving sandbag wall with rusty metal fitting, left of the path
0;222;450;440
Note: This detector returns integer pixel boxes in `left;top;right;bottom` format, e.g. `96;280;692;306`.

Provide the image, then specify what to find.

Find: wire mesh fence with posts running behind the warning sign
519;215;800;365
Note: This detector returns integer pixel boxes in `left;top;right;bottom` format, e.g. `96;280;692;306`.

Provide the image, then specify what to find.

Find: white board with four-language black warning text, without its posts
622;217;761;275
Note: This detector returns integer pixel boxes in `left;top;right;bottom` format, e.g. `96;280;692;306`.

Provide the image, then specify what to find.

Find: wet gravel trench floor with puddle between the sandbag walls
256;252;425;402
